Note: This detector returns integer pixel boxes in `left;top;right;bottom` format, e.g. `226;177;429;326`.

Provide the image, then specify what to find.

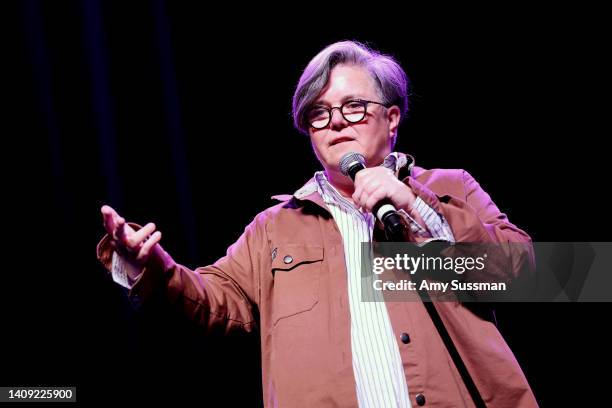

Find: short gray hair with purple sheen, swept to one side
293;41;409;134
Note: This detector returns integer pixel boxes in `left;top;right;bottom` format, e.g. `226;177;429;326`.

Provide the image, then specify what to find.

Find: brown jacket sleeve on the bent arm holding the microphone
404;170;535;286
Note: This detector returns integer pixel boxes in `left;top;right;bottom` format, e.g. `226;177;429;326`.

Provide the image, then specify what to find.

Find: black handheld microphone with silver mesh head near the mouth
339;152;405;241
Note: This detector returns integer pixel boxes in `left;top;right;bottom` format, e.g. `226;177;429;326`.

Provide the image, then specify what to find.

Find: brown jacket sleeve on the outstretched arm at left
97;214;271;333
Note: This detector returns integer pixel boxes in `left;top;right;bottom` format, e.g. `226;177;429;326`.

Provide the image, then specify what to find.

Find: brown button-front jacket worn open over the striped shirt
98;167;537;407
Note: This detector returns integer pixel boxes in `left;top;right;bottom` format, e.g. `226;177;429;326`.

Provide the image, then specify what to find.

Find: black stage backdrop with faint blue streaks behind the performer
5;0;610;406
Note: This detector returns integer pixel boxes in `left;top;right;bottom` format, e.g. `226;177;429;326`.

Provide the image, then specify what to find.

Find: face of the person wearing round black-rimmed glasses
309;65;400;172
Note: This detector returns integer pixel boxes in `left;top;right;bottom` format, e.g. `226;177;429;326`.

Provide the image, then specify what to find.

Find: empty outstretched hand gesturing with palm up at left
101;205;161;266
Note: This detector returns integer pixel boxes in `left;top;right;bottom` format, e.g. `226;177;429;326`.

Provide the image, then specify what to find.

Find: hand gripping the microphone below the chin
353;166;416;212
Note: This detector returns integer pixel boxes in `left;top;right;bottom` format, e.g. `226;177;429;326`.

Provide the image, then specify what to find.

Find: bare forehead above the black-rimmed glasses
315;65;377;104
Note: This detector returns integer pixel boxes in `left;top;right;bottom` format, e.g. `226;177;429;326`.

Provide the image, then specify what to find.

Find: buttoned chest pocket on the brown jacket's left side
272;244;323;326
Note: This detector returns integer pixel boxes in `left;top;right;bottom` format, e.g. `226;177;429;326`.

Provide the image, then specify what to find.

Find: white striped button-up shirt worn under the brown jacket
315;153;454;408
